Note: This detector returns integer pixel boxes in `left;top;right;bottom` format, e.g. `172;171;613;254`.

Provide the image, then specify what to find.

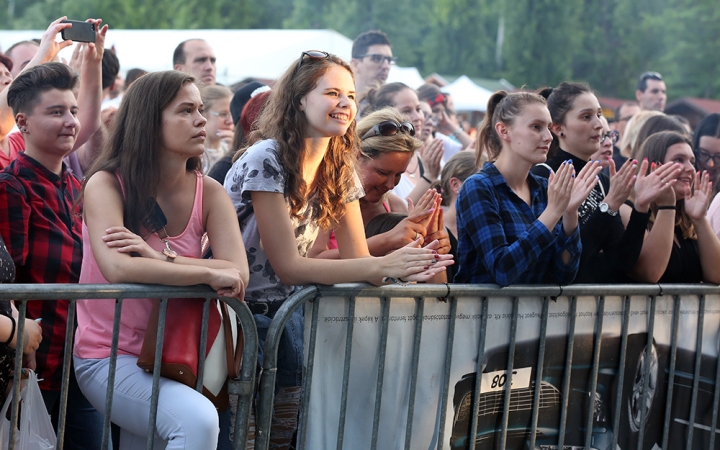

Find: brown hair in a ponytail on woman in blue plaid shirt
476;91;547;163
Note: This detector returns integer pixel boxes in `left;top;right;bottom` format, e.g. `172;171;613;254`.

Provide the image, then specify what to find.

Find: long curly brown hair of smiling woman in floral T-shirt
238;54;358;230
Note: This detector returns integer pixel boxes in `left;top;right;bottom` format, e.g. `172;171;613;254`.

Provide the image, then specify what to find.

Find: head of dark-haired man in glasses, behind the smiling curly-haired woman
350;30;397;95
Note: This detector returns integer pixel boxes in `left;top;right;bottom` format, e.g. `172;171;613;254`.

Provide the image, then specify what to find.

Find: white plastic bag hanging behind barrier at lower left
17;370;57;450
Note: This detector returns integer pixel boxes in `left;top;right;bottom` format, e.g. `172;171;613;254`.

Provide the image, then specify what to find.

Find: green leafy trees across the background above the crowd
0;0;720;98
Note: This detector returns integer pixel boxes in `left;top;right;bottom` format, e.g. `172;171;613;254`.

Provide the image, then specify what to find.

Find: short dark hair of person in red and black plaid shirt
7;62;78;114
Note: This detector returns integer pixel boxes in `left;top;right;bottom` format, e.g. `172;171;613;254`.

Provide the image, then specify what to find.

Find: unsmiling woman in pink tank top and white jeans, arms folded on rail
74;71;249;449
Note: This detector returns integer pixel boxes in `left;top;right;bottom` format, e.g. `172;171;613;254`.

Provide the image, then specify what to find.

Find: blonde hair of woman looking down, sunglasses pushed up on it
357;107;422;158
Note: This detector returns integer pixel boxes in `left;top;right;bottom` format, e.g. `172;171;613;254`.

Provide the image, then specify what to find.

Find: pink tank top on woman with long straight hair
74;172;205;359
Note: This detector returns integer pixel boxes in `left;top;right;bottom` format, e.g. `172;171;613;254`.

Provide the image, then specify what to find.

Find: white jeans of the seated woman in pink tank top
75;355;219;450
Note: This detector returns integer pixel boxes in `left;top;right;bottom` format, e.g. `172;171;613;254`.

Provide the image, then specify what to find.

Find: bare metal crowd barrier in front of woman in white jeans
0;284;258;450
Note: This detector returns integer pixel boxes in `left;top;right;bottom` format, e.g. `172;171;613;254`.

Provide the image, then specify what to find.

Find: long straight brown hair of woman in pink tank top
83;70;201;234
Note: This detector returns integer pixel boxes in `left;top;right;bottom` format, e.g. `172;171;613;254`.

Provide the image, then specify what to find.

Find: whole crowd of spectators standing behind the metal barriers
0;18;720;449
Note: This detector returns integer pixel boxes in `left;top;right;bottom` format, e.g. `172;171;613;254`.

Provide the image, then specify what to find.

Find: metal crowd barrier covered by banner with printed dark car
255;284;720;450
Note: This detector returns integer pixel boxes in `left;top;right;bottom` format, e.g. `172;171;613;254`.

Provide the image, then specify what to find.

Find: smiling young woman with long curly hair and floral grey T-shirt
225;51;452;446
